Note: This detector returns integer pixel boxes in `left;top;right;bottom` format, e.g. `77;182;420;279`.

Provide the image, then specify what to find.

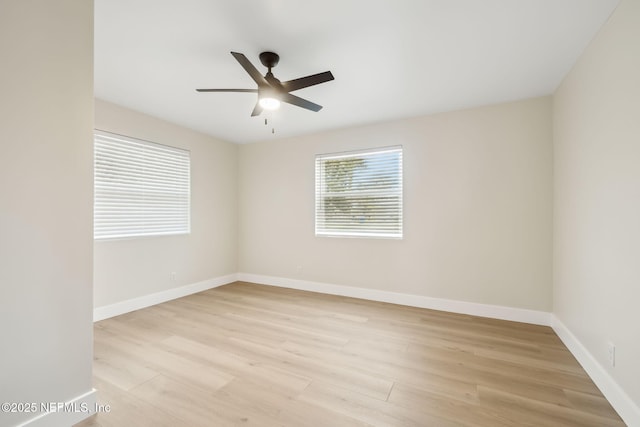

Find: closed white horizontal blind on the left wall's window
93;131;191;239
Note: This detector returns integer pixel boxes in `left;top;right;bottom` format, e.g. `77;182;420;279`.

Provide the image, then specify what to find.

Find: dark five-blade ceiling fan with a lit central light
196;52;333;117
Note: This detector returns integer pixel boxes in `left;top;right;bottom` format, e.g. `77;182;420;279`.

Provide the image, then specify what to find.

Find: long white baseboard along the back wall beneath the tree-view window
237;273;551;326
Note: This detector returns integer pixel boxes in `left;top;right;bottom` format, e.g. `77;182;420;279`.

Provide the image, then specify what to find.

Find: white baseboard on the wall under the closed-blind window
93;274;237;322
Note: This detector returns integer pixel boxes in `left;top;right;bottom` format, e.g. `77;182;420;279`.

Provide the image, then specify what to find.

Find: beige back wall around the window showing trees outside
239;97;552;311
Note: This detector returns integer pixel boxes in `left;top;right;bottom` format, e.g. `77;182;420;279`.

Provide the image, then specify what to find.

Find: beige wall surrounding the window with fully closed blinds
94;100;237;307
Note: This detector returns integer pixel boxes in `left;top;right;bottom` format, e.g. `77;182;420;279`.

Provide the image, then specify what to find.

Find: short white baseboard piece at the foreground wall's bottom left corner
16;389;96;427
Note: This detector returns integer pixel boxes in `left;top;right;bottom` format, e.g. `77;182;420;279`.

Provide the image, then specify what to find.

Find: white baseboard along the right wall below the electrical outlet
551;315;640;427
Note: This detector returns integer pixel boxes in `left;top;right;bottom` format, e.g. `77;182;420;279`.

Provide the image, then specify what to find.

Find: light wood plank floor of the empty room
78;282;624;427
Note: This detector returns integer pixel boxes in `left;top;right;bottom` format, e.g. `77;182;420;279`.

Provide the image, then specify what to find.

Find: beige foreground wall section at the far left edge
0;0;93;427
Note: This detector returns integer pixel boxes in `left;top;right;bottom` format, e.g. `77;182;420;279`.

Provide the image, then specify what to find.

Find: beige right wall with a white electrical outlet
553;0;640;406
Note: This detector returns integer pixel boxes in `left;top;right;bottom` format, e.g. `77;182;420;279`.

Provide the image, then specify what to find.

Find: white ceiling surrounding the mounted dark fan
95;0;618;143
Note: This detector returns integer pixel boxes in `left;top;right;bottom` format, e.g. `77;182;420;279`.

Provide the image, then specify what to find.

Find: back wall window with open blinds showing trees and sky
316;147;402;238
